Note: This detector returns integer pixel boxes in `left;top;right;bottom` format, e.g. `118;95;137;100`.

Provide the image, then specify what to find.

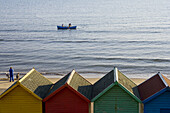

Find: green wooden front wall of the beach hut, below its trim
94;85;139;113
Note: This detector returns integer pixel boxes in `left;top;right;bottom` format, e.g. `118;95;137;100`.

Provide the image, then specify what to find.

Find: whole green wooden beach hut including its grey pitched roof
92;68;142;113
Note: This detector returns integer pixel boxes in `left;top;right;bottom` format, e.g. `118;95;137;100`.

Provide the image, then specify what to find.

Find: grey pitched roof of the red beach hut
45;70;92;101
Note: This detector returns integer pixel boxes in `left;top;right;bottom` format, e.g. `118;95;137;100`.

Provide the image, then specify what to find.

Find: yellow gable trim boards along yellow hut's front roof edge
0;81;42;100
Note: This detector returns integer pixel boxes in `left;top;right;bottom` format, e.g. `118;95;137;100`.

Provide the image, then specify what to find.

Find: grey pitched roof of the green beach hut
92;67;136;98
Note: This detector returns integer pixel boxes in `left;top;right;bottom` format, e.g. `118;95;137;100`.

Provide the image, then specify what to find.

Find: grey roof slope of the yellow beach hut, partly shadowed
19;68;53;99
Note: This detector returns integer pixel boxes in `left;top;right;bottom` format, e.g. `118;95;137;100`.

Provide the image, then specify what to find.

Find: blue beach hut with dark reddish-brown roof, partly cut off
133;73;170;113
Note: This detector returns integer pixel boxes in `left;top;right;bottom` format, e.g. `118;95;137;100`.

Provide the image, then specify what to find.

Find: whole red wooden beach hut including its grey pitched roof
43;70;92;113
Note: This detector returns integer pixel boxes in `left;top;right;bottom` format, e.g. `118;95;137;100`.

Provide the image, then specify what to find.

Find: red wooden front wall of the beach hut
45;87;90;113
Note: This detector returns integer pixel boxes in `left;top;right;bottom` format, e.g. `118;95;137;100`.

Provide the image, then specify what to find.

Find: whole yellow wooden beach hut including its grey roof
0;69;52;113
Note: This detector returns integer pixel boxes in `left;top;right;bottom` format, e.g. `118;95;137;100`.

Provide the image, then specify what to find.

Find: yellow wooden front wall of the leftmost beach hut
0;85;42;113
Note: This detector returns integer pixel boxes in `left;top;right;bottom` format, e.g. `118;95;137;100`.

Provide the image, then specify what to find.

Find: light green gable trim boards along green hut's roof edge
92;81;141;103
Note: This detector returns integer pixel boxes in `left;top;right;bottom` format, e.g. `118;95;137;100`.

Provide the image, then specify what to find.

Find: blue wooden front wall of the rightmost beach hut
144;90;170;113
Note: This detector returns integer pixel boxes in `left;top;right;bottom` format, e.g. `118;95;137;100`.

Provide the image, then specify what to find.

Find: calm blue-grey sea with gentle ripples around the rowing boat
0;0;170;77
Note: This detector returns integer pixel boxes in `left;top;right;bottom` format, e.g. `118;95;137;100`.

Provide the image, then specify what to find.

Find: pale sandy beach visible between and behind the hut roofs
0;78;146;94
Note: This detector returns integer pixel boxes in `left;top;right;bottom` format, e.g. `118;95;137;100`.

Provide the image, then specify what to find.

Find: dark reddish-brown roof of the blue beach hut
133;72;170;101
